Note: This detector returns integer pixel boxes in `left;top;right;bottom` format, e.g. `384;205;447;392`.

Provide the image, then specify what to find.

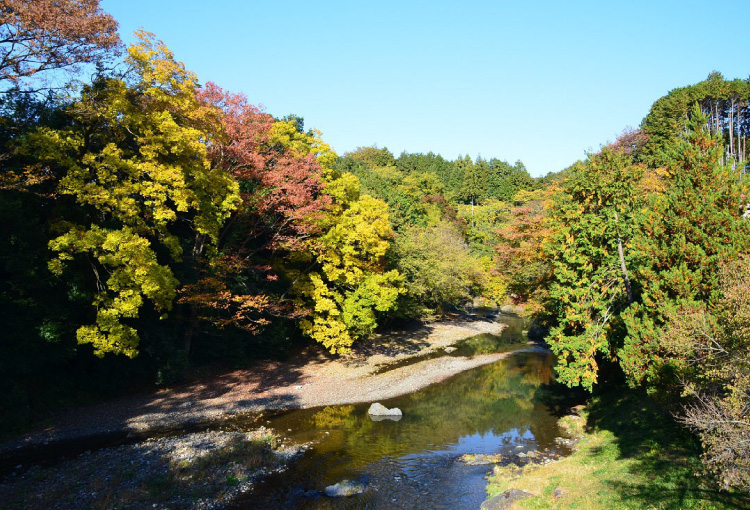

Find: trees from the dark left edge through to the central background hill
0;0;541;430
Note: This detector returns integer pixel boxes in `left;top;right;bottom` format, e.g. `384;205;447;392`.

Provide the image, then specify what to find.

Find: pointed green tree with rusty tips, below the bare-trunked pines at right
619;106;750;384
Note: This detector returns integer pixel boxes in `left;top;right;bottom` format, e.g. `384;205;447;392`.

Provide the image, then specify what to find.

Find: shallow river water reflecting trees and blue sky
234;316;568;510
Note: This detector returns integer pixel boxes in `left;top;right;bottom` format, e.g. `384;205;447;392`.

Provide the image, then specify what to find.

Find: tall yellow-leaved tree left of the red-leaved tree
32;32;239;357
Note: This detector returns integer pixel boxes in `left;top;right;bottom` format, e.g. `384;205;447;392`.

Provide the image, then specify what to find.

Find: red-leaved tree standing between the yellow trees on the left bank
182;83;331;332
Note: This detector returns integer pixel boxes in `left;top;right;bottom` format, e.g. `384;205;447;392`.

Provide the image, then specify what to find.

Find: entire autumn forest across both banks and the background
0;0;750;502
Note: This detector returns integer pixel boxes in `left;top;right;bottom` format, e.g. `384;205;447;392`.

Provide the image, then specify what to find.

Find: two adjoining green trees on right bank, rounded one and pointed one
545;109;750;390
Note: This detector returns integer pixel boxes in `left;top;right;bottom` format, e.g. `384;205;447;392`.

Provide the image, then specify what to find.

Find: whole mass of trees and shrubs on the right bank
501;73;750;490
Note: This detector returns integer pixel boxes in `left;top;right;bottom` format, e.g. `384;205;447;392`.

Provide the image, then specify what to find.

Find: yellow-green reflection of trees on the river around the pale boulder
296;353;557;468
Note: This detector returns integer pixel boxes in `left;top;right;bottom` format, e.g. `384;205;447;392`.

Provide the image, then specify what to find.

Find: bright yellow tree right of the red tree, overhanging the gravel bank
299;171;405;353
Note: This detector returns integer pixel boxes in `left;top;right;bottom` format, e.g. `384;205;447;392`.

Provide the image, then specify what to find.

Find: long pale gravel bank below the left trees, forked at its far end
0;319;507;457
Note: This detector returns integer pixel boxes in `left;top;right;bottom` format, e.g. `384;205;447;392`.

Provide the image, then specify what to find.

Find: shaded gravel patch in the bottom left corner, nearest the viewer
0;428;306;510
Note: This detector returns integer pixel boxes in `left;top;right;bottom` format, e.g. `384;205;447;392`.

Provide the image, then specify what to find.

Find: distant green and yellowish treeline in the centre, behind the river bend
337;147;544;318
